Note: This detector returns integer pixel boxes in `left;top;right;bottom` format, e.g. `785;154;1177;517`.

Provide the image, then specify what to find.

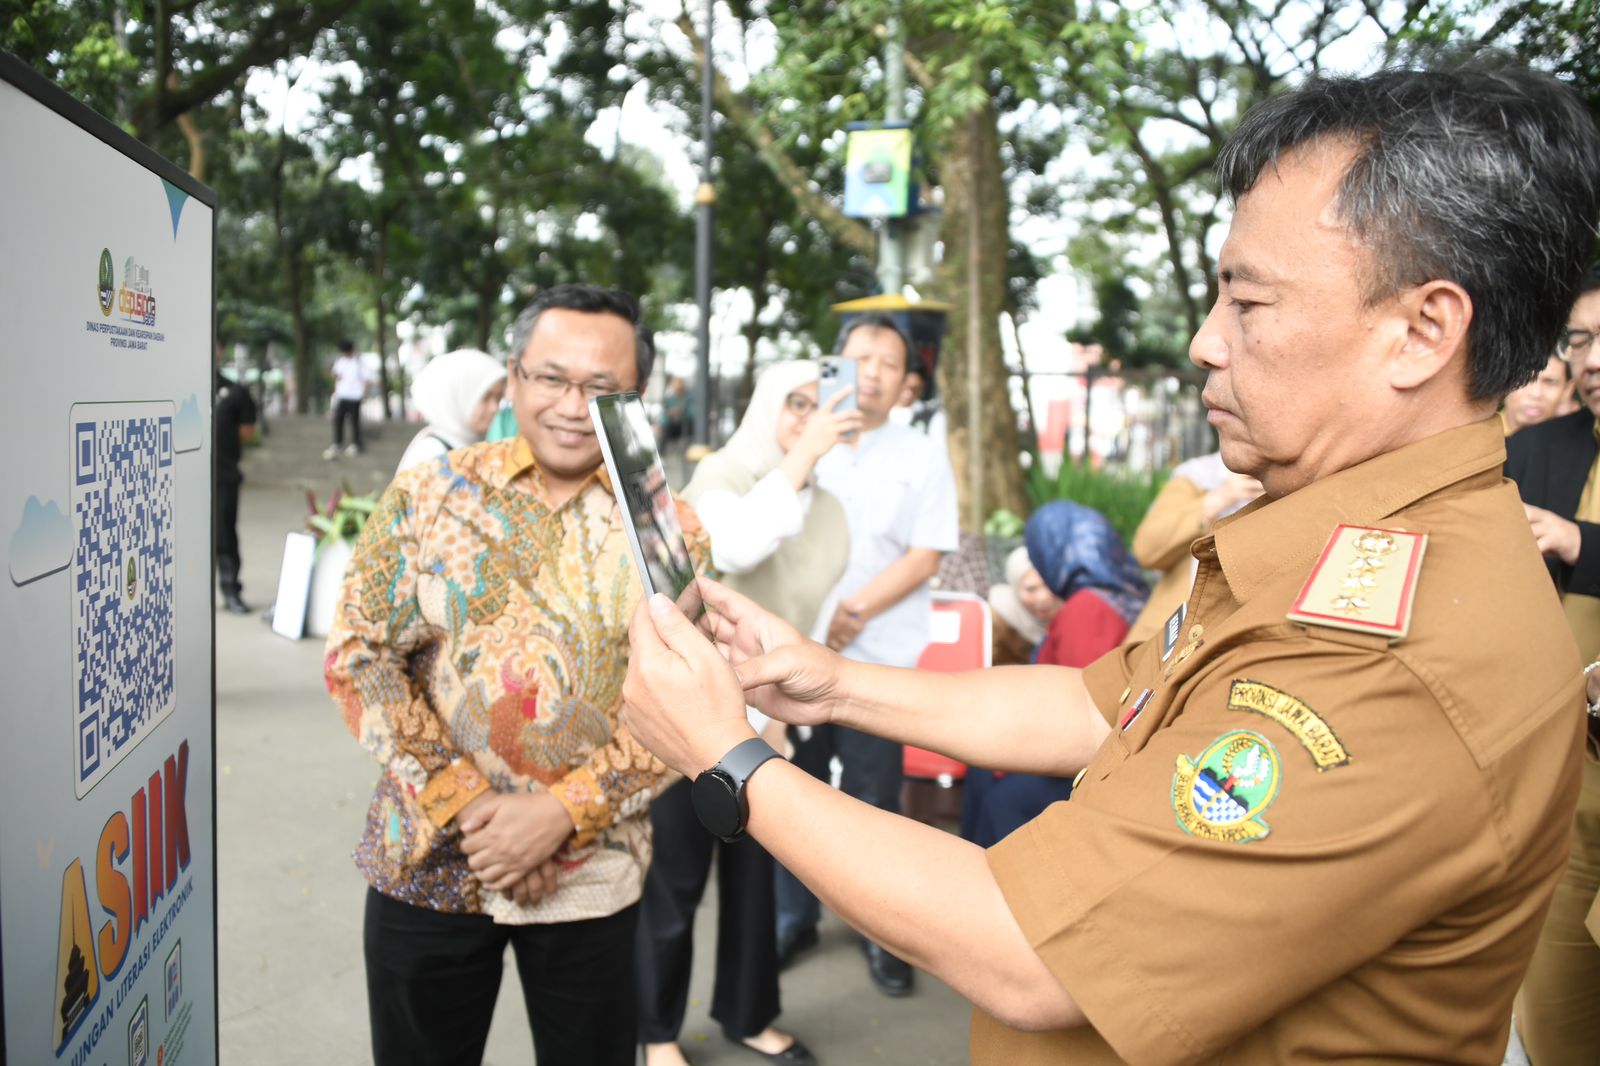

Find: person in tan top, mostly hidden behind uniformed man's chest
1126;451;1261;640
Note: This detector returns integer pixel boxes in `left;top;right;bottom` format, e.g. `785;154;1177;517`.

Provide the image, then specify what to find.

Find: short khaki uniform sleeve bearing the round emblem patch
989;639;1506;1063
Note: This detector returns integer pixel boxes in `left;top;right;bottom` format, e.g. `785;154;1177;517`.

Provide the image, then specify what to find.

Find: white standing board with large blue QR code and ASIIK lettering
0;53;218;1066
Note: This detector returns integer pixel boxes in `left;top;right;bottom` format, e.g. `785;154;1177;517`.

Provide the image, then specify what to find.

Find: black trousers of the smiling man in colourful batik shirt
363;888;638;1066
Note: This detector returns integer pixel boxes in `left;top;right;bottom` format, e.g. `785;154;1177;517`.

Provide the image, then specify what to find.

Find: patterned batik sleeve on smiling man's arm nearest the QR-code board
323;479;490;829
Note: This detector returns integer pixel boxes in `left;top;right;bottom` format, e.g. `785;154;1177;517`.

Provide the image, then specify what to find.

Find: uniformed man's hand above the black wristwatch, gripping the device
622;592;755;778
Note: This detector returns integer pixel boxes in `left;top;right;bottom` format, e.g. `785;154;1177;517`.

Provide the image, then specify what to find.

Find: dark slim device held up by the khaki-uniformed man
589;392;704;621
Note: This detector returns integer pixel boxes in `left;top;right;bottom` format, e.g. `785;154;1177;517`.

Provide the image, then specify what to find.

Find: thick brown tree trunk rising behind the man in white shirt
936;94;1027;521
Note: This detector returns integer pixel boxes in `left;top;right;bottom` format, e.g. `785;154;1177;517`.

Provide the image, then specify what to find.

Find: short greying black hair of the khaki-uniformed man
1218;58;1600;400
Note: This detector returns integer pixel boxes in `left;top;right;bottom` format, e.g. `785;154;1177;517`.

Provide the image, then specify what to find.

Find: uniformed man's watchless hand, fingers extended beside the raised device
699;578;848;725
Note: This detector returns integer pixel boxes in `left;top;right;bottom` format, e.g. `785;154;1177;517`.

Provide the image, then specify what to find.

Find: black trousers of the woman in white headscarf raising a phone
640;781;779;1037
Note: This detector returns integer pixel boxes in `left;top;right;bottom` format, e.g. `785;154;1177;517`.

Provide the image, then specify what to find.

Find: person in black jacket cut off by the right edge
1506;262;1600;1066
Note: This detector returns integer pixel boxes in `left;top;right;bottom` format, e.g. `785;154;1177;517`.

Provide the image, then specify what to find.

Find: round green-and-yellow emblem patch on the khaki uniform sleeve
1173;730;1283;844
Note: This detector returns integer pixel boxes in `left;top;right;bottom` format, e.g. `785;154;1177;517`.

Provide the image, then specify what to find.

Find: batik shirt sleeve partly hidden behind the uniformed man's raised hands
550;499;710;848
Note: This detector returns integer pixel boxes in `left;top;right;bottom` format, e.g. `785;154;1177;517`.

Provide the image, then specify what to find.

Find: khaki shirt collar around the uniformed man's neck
1214;416;1506;602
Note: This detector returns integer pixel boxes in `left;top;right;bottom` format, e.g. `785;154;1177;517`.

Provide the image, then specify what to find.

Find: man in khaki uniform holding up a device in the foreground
624;69;1600;1066
